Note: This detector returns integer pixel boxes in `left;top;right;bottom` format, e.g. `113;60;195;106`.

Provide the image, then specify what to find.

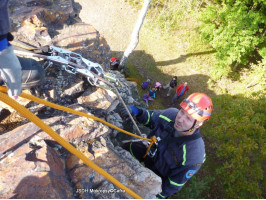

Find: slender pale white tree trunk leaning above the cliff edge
119;0;151;70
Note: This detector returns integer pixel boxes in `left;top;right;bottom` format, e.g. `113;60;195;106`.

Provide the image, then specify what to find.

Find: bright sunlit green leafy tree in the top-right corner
199;0;266;73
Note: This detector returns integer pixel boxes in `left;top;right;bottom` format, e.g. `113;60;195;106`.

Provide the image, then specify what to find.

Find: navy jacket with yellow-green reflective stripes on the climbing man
137;108;205;198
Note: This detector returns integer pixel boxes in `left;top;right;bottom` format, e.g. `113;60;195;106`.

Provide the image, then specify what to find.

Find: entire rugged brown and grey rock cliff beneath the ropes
0;0;161;199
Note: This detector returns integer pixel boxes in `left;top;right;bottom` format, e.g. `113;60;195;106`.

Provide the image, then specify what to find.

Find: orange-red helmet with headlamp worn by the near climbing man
180;93;213;122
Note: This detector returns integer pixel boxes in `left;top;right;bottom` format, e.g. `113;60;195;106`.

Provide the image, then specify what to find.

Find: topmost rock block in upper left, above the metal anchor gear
9;0;76;46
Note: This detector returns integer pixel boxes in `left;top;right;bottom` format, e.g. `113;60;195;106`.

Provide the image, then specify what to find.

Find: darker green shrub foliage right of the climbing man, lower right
204;95;266;198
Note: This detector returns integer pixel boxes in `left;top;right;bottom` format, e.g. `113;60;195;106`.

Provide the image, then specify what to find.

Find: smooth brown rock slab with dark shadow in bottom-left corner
0;124;73;199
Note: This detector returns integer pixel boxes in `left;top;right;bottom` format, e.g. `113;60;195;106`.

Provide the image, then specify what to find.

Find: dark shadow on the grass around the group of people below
111;50;214;109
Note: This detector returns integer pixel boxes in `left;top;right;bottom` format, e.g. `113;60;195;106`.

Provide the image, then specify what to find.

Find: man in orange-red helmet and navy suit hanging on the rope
122;93;213;199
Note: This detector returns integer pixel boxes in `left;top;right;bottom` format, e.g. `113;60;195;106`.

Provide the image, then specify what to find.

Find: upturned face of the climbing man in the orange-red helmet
174;108;195;132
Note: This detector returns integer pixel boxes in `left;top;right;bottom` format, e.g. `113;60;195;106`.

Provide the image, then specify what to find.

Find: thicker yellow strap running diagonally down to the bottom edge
0;90;141;199
